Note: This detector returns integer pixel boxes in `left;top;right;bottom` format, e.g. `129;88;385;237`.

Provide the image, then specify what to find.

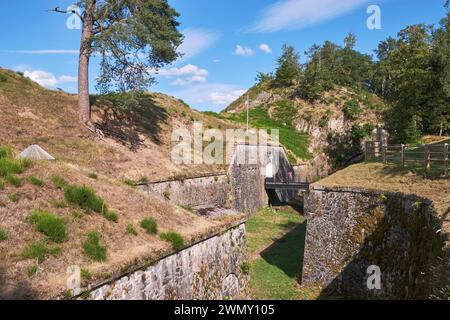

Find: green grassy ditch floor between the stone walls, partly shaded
246;209;319;300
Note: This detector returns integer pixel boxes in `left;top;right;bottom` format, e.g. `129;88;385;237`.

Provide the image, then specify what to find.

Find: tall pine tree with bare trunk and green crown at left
55;0;183;122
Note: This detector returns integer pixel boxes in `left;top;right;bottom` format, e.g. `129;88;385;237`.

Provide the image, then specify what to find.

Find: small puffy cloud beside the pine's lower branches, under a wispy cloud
151;64;209;86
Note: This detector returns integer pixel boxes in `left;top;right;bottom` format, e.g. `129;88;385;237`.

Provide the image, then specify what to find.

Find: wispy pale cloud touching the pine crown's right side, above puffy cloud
178;28;219;60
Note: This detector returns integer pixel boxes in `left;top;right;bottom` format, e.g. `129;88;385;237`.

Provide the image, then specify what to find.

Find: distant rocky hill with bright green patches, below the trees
218;81;385;170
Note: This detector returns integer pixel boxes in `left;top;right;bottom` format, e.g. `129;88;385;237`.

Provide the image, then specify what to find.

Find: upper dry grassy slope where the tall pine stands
0;69;236;181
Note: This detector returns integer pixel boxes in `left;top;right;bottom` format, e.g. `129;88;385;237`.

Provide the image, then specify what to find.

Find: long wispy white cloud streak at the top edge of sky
249;0;368;32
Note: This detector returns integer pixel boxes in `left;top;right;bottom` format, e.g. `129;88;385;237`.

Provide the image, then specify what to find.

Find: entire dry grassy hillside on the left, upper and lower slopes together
0;69;246;299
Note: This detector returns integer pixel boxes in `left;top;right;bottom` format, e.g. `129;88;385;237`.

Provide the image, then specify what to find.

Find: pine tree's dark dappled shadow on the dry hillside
91;94;169;150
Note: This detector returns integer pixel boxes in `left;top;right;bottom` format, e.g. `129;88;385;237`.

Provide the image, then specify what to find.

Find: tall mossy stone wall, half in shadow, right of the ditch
302;187;448;299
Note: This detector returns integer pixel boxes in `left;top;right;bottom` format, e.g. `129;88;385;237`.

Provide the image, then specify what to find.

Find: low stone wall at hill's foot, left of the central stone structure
139;174;228;207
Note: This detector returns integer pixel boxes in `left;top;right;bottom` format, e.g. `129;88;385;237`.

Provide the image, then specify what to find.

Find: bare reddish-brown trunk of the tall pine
78;0;96;123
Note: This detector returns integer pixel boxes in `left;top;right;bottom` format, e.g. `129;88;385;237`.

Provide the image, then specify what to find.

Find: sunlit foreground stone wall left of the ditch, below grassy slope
90;224;248;300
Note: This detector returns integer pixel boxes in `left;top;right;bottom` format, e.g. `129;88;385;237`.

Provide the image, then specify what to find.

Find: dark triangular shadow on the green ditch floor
261;221;306;280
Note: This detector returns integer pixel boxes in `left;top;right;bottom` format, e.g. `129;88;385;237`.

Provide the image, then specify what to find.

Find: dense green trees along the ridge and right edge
257;3;450;143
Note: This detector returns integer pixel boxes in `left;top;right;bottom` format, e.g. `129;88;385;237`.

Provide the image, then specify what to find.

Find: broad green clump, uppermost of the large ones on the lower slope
64;186;108;213
